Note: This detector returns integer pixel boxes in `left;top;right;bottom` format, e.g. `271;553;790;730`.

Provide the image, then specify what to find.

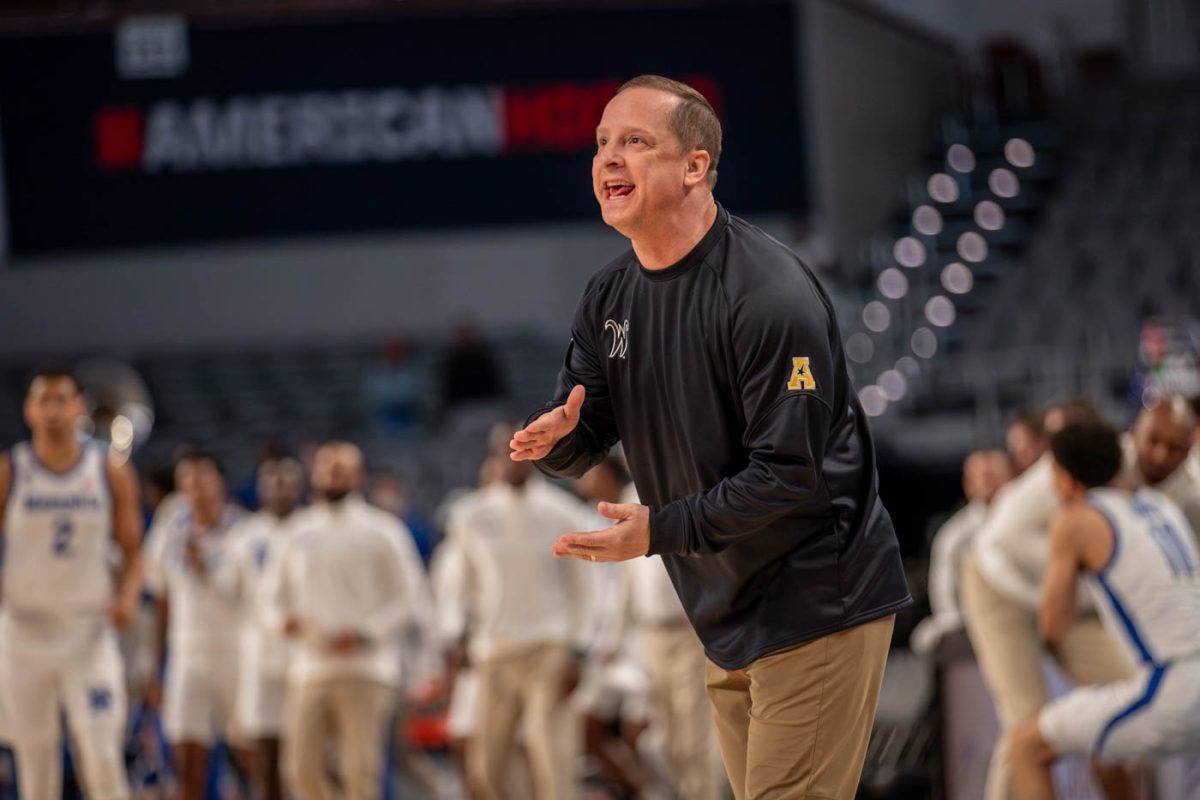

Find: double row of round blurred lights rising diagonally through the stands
846;138;1036;416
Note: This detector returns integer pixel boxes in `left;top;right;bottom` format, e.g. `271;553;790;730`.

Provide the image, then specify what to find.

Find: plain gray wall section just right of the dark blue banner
800;0;958;264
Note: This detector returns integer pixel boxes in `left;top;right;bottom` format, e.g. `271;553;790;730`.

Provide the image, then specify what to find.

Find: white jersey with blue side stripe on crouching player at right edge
1087;488;1200;666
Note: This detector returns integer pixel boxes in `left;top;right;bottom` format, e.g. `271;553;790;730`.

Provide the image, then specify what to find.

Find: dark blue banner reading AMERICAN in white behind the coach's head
0;2;805;255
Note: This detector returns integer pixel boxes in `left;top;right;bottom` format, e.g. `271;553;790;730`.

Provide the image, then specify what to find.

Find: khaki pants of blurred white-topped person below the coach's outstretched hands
467;644;582;800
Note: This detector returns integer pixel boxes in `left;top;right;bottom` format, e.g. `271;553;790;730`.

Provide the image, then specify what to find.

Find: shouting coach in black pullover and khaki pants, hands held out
510;76;911;800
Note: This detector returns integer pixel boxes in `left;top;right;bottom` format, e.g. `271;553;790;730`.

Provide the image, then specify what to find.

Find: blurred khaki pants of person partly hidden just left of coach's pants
641;622;720;800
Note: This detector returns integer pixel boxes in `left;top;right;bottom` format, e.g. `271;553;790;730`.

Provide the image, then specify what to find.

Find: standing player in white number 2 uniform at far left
0;369;142;800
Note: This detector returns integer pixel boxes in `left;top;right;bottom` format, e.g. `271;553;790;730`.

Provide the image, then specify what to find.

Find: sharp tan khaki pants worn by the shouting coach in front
707;614;895;800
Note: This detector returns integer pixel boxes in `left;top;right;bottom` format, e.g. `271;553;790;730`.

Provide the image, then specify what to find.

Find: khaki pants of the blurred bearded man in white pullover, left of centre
283;679;396;800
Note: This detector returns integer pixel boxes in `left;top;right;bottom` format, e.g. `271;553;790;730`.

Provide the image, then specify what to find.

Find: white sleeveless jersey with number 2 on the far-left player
4;441;113;616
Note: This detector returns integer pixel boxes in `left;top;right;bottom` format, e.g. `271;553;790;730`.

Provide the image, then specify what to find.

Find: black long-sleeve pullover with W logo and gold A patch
530;207;911;669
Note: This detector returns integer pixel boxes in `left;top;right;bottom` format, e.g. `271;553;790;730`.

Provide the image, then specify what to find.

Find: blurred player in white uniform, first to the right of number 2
145;451;247;800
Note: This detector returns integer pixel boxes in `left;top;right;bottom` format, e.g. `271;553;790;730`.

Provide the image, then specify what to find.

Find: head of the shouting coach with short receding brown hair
592;76;721;237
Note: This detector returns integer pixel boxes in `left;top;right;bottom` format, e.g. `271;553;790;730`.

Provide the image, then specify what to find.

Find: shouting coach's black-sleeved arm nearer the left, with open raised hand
509;281;618;477
